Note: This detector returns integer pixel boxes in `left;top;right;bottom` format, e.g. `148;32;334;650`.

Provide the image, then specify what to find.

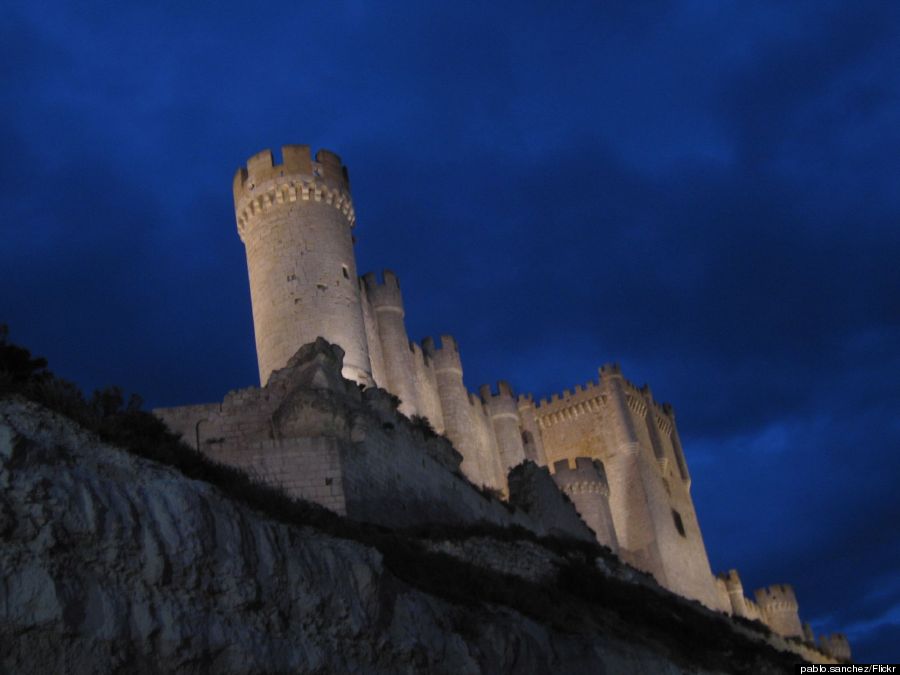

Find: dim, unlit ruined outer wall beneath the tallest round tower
154;339;584;536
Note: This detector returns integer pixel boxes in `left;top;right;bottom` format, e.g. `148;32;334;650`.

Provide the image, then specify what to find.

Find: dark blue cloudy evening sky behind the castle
0;0;900;661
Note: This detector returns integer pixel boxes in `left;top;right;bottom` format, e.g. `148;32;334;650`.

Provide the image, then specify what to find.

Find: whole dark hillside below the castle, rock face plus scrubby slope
0;398;808;674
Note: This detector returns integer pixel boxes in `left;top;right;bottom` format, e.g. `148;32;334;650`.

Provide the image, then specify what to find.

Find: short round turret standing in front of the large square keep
553;457;619;552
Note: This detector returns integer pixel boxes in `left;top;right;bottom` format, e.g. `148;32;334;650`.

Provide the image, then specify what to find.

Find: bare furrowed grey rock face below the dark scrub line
0;400;784;674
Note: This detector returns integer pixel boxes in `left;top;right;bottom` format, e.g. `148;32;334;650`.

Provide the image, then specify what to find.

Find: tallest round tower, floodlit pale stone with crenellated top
234;145;372;385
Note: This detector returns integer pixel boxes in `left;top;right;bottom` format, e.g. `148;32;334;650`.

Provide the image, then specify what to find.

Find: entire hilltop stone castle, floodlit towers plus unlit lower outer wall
155;145;849;659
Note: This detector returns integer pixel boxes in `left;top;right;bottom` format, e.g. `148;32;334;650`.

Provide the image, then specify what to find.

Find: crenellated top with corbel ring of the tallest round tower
232;145;356;241
